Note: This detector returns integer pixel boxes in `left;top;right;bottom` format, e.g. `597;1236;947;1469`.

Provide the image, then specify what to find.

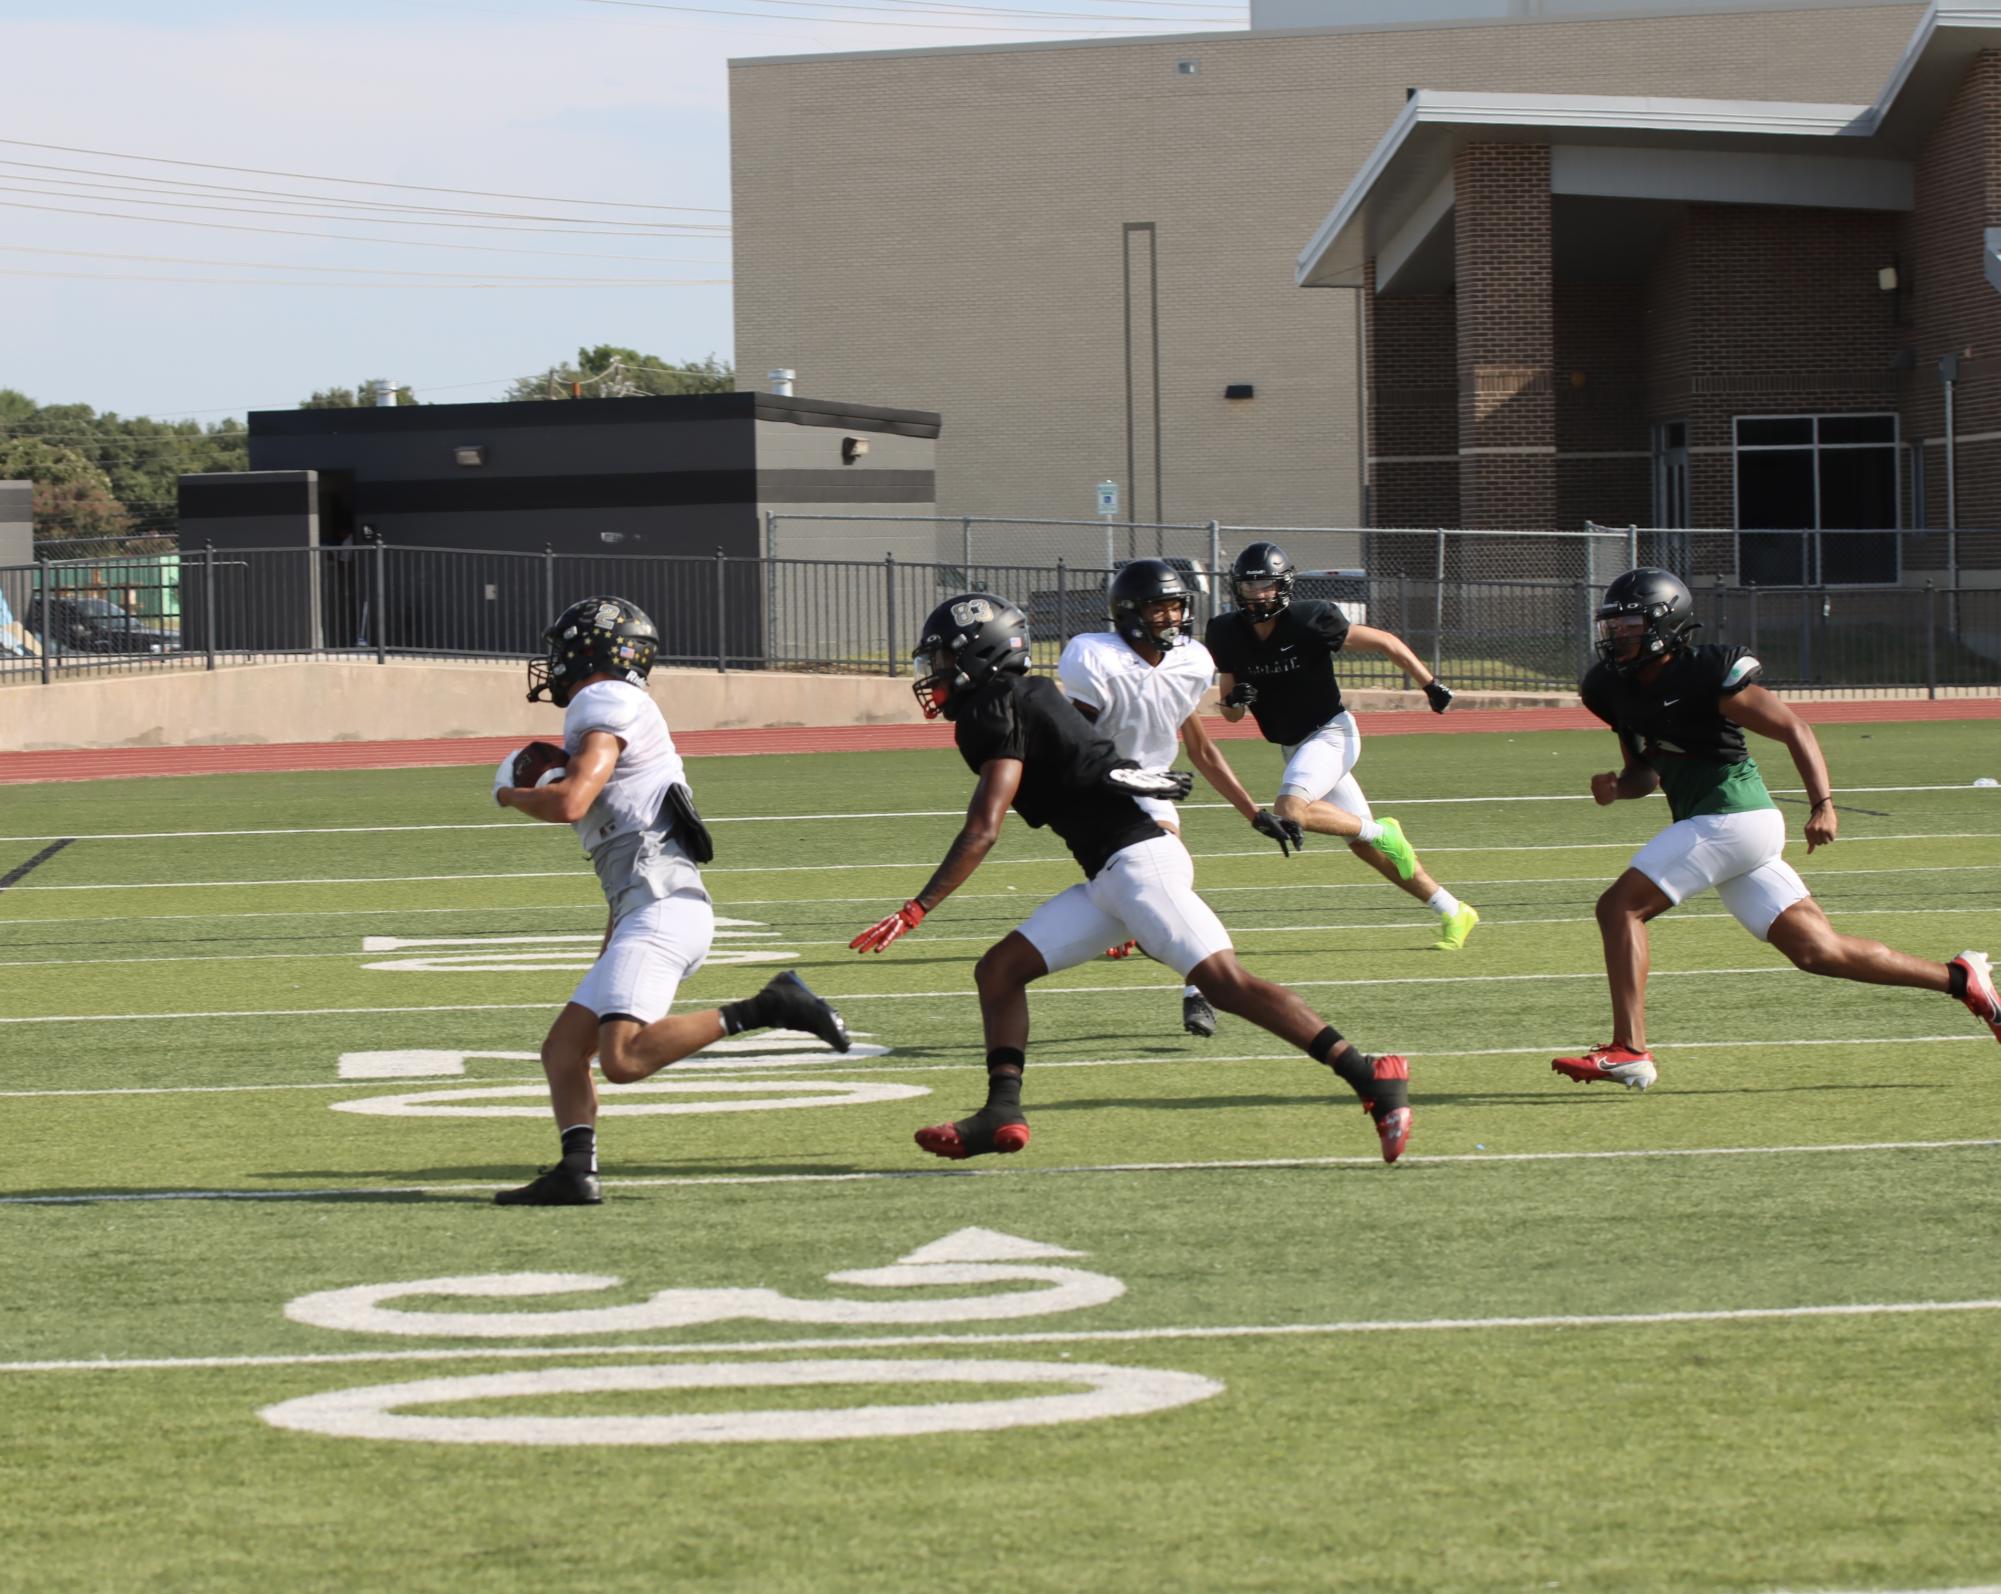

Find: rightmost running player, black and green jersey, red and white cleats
1551;568;2001;1090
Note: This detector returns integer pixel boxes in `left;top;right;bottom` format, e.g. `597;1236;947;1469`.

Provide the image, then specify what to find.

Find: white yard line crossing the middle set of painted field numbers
0;1034;1987;1100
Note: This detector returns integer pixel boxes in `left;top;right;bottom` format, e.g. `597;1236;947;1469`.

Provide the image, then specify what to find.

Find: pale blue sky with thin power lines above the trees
0;0;1243;420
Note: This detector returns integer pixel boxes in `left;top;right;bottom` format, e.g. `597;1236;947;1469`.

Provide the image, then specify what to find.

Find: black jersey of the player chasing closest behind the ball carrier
952;674;1161;878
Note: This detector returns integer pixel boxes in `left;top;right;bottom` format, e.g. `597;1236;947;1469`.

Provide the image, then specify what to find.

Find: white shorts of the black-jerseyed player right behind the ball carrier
1021;830;1231;980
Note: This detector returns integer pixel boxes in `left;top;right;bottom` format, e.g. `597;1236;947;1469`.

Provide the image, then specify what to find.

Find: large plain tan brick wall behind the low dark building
730;6;1921;524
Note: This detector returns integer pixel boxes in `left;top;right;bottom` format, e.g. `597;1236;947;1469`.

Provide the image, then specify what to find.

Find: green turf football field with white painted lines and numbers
0;724;2001;1594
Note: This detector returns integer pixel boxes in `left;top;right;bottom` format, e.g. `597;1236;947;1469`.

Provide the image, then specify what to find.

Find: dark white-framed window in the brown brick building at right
1737;416;1899;586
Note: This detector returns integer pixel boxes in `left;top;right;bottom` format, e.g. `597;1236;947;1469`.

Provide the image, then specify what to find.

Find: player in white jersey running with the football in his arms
494;598;848;1206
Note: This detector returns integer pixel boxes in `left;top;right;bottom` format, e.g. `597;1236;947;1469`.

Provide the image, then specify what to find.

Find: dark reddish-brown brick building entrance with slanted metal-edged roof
1299;6;2001;586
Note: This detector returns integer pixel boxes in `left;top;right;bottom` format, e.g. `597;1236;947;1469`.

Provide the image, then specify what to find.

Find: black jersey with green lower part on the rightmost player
1577;642;1773;820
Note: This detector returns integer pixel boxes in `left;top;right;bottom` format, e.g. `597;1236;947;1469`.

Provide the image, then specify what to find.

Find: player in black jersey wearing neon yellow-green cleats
1207;542;1481;952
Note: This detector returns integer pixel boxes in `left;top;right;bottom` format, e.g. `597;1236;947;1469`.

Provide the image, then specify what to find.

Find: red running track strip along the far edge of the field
0;698;2001;784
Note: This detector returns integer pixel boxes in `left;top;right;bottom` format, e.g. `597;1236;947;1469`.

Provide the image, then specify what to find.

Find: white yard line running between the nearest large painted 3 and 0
0;1300;2001;1374
